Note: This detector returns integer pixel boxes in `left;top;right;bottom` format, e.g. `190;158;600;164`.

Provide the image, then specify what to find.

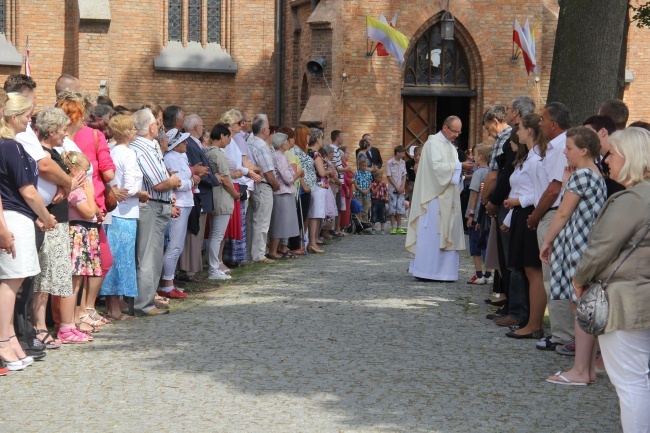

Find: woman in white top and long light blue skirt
99;114;149;320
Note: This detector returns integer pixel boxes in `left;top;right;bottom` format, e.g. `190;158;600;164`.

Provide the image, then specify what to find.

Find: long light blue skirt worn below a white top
99;217;138;297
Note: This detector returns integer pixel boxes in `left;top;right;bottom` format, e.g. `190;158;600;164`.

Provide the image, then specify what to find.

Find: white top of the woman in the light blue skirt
111;145;143;219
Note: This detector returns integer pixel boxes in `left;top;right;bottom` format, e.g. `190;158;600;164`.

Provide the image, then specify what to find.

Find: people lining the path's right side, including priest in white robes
406;96;650;432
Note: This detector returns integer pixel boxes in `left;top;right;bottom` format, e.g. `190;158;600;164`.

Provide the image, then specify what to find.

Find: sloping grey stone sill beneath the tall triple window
153;41;238;74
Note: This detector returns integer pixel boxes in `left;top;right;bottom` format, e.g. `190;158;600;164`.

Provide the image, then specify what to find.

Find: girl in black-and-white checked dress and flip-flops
539;126;607;385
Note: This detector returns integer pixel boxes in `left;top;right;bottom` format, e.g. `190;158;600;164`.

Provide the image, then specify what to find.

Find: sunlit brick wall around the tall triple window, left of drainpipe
0;0;275;124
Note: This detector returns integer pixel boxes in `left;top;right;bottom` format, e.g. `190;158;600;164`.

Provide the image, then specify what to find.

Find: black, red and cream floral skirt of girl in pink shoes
70;221;102;277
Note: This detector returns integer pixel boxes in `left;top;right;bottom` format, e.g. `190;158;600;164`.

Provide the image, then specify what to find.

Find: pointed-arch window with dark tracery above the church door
404;22;470;88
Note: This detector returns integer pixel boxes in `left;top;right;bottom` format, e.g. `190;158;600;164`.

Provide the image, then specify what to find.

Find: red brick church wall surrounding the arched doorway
284;0;650;164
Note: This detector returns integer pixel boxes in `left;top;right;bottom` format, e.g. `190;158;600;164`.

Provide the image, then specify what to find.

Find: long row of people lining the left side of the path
0;74;410;375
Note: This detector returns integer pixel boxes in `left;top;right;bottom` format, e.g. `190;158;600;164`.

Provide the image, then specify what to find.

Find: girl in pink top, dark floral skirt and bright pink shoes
59;152;102;342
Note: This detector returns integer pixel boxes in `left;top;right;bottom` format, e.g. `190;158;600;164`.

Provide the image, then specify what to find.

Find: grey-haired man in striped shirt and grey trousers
130;108;181;316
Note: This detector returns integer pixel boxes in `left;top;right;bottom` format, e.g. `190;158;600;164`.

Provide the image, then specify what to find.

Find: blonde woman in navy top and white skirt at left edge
0;93;56;370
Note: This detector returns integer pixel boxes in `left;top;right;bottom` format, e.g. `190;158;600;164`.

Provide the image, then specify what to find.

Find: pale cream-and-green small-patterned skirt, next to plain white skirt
34;222;72;298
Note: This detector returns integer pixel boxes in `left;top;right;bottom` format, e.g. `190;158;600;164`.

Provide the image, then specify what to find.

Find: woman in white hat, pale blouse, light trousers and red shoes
158;128;201;299
